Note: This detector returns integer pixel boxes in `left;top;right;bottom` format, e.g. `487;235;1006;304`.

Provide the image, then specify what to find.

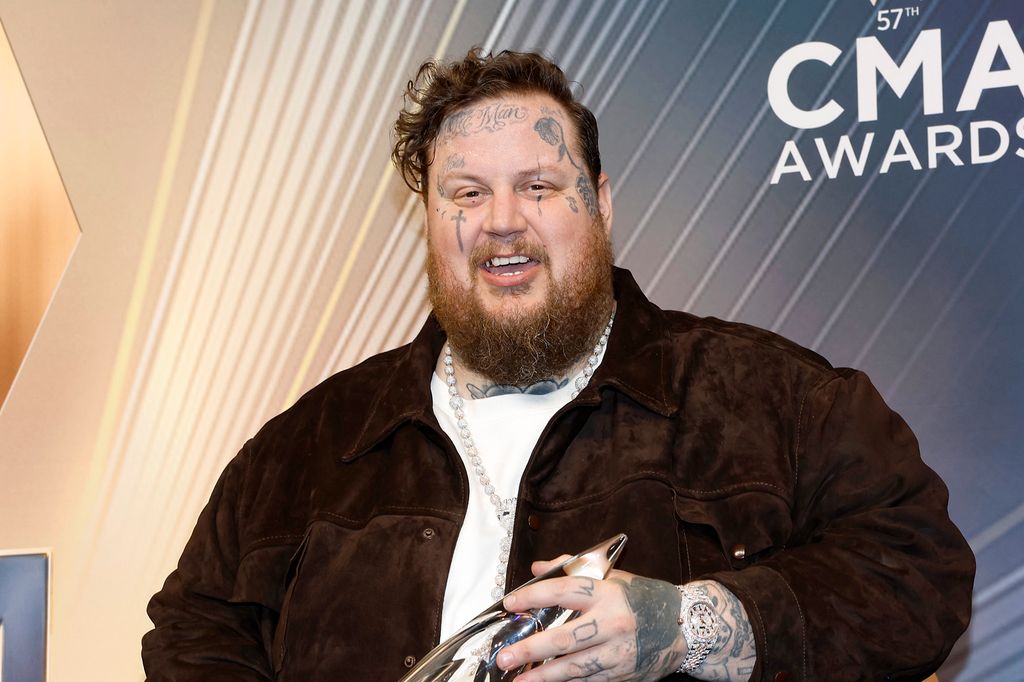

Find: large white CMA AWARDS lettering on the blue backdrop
768;20;1024;184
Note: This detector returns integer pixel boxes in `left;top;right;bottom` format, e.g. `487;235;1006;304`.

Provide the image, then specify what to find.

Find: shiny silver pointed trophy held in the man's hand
400;534;626;682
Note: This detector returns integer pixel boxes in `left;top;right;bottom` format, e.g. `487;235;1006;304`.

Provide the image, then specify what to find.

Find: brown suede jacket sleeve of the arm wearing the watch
706;370;975;681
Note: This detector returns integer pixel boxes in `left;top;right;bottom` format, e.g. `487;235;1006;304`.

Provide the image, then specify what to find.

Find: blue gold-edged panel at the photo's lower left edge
0;552;50;682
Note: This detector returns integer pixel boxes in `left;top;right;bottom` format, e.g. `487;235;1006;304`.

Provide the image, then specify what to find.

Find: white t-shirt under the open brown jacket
430;372;572;641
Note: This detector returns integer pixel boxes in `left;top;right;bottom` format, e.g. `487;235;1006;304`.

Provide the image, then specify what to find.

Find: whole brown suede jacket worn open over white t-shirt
142;270;974;682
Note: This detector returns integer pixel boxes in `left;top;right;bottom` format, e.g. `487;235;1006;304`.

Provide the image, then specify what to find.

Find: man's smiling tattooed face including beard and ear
425;92;612;387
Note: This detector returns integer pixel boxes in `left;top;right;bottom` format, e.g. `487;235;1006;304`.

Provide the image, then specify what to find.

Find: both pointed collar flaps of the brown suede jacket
333;267;679;461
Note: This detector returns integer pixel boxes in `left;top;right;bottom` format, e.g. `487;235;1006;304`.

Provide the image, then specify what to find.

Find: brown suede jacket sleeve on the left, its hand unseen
142;449;273;682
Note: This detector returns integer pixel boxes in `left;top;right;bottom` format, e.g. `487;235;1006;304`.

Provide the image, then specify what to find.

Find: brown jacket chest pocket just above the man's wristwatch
675;488;793;580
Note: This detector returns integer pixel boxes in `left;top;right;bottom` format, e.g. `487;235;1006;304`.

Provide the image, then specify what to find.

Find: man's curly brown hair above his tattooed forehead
391;47;601;202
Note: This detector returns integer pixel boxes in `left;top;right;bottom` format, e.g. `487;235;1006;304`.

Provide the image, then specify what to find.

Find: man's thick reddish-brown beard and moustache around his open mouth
427;218;614;387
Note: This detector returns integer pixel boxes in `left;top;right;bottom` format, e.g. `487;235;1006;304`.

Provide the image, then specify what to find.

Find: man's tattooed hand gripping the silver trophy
498;563;686;682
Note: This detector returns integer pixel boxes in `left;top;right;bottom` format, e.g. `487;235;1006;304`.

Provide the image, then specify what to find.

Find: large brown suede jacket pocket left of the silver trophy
272;515;457;682
